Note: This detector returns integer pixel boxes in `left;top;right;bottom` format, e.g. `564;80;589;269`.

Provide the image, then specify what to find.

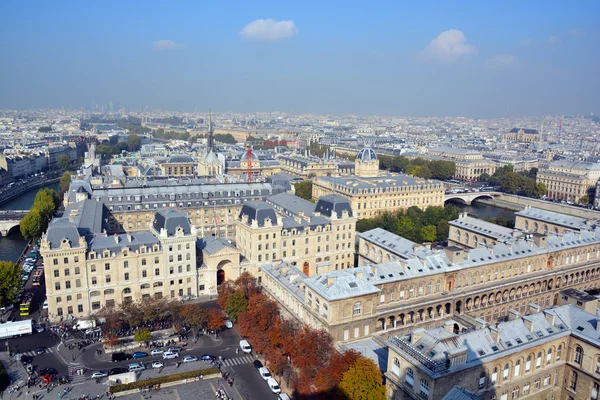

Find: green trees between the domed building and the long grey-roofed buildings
356;204;458;243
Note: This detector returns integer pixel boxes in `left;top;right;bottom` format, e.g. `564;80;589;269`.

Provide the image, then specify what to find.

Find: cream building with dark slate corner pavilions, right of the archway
235;193;357;276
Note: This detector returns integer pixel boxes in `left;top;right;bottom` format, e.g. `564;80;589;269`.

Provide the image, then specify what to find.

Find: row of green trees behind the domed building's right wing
378;154;456;180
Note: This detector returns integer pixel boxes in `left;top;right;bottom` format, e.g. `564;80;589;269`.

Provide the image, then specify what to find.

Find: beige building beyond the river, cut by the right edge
536;160;600;203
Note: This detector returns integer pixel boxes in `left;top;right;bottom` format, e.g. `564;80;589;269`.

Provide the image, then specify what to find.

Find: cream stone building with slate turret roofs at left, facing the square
40;205;198;320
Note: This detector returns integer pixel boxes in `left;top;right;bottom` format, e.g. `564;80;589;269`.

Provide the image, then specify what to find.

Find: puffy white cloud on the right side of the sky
418;29;476;62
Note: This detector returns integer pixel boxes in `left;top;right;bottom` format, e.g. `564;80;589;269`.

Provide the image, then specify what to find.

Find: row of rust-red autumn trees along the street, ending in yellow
218;273;385;400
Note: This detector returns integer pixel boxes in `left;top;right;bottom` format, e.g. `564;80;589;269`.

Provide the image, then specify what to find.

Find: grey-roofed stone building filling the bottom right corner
385;293;600;400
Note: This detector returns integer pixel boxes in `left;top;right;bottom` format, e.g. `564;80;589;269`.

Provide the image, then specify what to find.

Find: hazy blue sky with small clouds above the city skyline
0;0;600;118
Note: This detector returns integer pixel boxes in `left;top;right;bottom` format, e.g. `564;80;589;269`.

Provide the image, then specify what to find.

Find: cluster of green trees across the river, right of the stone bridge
479;165;548;197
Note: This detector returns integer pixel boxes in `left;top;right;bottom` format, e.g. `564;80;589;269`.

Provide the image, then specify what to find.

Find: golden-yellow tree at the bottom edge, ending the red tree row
338;357;385;400
